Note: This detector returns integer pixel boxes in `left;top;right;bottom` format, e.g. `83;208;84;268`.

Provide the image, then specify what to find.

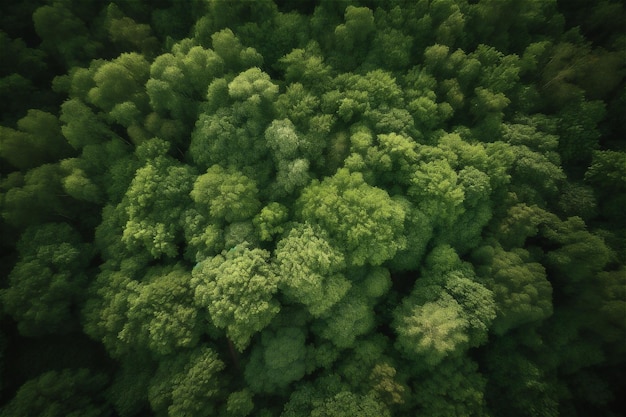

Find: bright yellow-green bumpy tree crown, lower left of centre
192;243;280;351
